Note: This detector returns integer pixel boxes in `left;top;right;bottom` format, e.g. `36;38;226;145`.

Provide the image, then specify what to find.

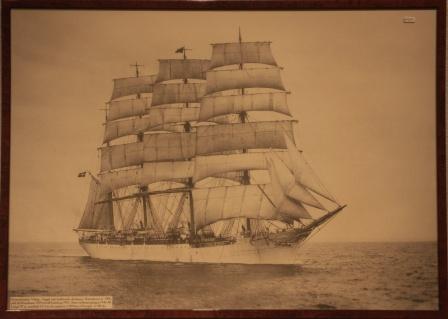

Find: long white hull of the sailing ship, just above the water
80;238;299;265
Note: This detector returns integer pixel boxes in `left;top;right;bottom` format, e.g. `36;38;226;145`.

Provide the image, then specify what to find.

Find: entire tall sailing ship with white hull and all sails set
75;33;345;264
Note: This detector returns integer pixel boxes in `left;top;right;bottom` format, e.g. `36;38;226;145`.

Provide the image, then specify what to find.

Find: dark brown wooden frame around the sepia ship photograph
0;0;448;319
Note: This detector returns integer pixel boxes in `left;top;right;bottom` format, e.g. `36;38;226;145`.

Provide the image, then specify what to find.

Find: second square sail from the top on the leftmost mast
107;97;151;121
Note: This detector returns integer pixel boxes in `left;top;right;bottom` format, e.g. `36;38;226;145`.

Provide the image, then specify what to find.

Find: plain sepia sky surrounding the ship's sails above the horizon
10;10;437;241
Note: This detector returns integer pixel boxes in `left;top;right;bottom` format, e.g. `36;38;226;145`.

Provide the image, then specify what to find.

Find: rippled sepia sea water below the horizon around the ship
8;242;438;310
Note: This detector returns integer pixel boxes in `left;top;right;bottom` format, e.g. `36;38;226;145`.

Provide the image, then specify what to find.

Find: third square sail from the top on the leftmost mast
103;117;150;143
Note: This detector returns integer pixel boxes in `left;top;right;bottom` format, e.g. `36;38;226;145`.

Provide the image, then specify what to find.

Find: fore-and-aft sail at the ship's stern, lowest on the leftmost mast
78;179;114;230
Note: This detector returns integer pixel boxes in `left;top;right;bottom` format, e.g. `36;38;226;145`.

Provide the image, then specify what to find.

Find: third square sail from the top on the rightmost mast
199;92;291;121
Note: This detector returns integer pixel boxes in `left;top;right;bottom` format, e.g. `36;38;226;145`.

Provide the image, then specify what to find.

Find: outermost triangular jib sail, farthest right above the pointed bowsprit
284;135;337;204
